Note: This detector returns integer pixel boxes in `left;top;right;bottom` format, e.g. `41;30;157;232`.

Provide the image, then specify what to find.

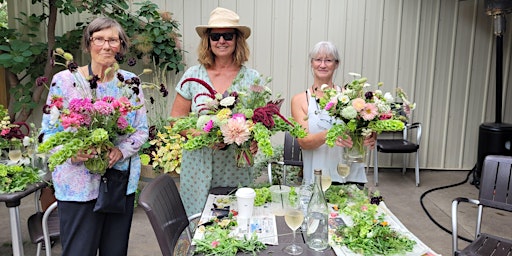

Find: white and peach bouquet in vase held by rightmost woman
319;73;416;162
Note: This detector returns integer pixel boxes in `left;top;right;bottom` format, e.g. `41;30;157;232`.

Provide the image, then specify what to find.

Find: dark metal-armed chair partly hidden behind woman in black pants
27;202;60;256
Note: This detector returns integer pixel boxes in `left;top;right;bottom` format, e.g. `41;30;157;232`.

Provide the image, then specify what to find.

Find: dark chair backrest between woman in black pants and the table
139;174;190;256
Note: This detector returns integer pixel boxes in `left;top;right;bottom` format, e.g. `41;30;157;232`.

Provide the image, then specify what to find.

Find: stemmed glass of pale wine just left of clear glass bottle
283;200;304;255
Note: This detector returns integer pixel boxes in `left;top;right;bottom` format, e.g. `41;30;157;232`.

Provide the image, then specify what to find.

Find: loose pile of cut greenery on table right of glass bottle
326;185;416;255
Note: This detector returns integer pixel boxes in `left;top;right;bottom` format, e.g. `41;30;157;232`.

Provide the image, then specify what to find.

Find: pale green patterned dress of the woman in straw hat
176;65;260;216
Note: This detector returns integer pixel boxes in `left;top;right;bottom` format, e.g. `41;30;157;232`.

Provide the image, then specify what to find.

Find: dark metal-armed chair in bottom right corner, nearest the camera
452;155;512;256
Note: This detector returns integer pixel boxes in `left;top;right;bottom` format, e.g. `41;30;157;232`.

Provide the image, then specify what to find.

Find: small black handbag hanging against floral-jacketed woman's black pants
94;159;131;213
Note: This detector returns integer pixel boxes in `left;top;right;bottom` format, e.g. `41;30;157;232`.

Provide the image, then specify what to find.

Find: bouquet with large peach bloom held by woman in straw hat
172;77;306;167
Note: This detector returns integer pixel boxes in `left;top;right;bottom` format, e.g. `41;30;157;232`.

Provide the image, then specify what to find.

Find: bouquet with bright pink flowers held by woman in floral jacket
38;49;142;175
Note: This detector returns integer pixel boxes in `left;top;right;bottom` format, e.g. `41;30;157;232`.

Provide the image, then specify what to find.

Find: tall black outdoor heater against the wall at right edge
472;0;512;184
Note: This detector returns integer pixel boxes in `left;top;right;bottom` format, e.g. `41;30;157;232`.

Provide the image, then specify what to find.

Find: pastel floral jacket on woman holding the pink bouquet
41;70;148;202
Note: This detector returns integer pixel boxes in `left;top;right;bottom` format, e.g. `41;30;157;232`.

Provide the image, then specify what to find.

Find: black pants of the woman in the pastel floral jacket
58;194;135;256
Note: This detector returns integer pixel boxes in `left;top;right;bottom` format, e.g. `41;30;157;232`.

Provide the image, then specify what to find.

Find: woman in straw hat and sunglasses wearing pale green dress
171;7;260;215
